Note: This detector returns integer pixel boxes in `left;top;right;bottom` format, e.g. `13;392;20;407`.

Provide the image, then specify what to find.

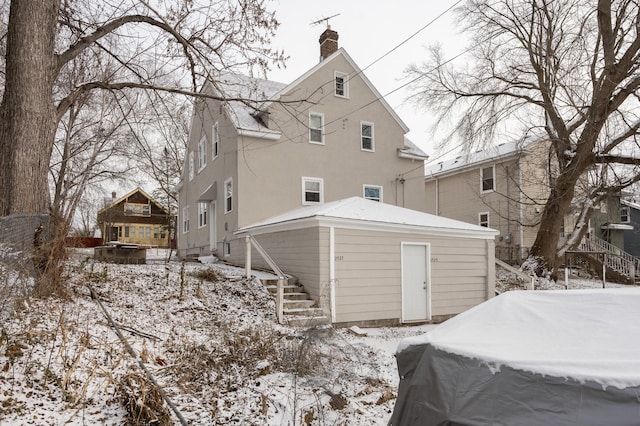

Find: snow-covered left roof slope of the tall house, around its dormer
215;73;286;133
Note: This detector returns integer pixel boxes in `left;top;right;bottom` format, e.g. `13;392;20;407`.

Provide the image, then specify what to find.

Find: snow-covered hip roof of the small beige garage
239;197;498;239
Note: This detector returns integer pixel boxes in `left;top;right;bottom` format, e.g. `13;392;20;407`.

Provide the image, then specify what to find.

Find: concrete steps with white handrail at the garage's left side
261;275;331;327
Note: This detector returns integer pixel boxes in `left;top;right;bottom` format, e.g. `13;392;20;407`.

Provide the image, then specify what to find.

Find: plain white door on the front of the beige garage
402;243;431;322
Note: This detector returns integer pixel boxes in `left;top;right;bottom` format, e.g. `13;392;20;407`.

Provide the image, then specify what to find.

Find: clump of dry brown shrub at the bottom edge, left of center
118;372;173;426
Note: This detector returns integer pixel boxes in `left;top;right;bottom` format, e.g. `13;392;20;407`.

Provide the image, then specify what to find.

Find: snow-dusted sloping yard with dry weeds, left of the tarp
0;250;434;426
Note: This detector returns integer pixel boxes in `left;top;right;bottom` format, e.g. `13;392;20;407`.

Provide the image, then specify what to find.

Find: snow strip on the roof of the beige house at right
425;138;540;178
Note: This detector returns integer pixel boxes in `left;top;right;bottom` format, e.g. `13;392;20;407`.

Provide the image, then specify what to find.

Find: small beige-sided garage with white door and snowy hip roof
238;197;498;325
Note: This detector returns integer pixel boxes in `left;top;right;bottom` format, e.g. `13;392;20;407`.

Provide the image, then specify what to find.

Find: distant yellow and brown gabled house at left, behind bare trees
98;188;173;247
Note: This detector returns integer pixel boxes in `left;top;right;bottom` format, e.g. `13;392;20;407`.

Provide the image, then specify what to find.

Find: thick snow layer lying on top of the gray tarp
398;288;640;389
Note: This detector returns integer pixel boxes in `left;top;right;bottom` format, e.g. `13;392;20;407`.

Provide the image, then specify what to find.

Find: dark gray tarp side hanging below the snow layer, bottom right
389;343;640;426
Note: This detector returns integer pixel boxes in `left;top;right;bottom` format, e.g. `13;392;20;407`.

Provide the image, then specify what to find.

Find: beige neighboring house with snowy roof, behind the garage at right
425;140;573;263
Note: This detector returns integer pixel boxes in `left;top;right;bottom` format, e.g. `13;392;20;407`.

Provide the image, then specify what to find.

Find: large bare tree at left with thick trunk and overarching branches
0;0;283;290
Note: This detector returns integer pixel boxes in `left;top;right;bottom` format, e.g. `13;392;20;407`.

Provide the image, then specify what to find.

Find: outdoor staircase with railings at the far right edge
574;236;640;284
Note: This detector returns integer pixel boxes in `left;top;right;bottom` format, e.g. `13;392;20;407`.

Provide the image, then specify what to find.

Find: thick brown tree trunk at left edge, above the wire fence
0;0;59;216
